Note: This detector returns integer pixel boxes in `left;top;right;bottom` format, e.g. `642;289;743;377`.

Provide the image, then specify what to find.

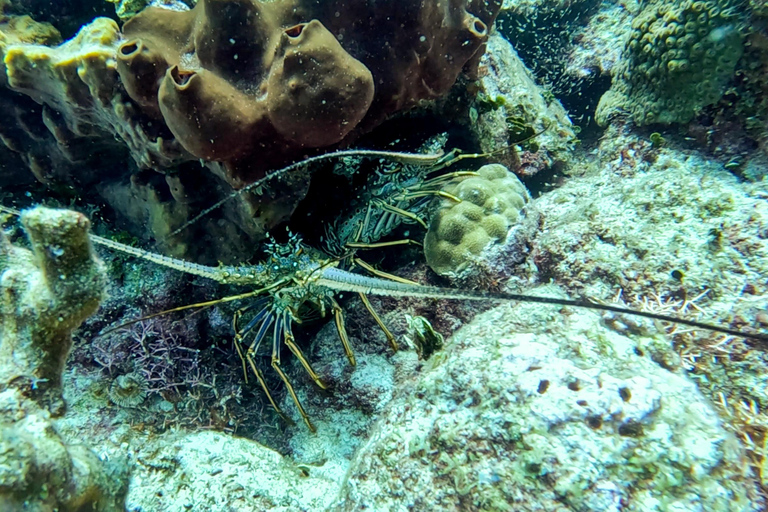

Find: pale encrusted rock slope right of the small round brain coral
532;128;768;304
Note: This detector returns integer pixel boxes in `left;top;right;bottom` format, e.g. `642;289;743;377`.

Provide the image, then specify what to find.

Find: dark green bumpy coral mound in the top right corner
595;0;743;125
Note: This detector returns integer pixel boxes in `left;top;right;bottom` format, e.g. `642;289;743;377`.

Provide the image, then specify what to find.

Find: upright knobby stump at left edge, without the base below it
0;208;105;409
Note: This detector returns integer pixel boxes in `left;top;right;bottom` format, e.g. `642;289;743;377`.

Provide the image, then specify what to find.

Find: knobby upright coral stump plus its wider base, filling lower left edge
0;208;127;512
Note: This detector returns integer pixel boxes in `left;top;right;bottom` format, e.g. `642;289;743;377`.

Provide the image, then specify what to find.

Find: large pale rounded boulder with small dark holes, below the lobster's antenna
338;296;759;512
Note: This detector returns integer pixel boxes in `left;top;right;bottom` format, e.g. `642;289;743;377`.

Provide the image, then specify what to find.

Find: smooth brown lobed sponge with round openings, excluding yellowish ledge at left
112;0;500;184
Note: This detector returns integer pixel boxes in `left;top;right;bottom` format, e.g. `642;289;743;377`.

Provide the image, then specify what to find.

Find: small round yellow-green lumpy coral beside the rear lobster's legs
424;164;530;275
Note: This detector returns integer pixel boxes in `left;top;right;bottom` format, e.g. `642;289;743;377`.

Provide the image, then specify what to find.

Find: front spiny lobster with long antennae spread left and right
0;150;768;432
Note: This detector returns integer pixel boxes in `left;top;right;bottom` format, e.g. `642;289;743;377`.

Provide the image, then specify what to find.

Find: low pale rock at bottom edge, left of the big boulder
127;432;338;512
